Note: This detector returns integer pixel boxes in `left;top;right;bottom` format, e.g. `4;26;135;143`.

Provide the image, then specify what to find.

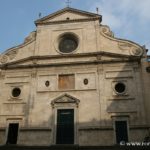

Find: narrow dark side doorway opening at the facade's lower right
115;121;128;144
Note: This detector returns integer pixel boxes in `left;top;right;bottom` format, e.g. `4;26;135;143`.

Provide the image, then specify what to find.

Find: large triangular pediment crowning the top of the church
35;7;101;24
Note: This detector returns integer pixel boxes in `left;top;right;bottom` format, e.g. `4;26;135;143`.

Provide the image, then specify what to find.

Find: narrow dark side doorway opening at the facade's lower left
6;123;19;144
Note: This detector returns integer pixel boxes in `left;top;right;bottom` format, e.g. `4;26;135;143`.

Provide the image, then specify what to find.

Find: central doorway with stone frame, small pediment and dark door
51;93;80;144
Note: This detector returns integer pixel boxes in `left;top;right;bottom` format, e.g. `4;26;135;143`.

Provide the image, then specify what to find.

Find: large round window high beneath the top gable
59;34;78;53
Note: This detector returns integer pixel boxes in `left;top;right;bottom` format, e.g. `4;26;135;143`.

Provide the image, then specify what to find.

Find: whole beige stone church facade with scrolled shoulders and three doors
0;7;150;146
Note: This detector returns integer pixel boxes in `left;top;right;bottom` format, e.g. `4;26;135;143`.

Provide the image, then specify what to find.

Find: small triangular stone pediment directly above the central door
51;93;80;105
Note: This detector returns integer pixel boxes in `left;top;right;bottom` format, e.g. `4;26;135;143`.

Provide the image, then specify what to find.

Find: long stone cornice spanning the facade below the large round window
0;51;141;69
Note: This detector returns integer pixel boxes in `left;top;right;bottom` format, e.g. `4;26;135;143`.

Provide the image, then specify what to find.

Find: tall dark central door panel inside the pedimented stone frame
56;109;74;144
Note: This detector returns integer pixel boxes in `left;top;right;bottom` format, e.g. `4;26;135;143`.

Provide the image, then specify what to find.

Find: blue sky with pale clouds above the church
0;0;150;54
